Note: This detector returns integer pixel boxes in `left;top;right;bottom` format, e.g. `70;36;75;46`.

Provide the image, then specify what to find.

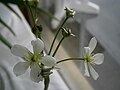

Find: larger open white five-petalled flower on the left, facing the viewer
11;38;56;82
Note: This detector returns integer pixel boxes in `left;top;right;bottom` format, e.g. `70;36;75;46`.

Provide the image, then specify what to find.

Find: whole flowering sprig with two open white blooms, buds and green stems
11;5;104;90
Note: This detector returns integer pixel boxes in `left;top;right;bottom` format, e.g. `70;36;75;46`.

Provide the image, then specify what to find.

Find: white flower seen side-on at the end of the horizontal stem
84;37;104;80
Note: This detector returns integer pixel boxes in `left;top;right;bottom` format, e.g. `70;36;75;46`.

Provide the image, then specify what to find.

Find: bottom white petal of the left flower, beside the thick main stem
30;65;43;83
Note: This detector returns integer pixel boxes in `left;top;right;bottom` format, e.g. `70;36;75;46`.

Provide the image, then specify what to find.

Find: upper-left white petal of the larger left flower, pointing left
11;44;31;57
